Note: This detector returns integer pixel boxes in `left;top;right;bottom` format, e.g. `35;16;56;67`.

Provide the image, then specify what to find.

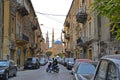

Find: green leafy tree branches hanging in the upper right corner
92;0;120;41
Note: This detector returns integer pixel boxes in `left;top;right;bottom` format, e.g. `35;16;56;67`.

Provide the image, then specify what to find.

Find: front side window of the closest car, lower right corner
95;60;108;80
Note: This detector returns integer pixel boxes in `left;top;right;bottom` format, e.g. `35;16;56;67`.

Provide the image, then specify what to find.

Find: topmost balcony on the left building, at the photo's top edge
17;0;30;16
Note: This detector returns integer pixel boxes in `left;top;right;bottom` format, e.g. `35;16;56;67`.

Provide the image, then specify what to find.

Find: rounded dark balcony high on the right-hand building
76;8;87;23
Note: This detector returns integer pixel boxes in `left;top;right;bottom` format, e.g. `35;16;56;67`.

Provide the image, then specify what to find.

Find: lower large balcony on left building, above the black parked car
16;34;29;45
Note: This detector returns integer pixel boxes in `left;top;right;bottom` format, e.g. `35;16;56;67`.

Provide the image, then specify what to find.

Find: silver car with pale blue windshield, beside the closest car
72;62;96;80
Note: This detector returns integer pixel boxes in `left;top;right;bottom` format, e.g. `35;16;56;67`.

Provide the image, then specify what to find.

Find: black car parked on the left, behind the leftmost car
24;57;40;69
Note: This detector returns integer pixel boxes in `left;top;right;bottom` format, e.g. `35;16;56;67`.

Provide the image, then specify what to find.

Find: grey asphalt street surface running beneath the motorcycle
9;65;73;80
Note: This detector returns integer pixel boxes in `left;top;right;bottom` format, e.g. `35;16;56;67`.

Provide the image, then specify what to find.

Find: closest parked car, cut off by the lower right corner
92;54;120;80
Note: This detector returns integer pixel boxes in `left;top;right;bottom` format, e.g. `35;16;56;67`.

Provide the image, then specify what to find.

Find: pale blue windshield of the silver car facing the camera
77;63;95;74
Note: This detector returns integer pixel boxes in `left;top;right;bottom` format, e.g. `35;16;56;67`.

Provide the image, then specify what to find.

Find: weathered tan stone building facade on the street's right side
64;0;120;60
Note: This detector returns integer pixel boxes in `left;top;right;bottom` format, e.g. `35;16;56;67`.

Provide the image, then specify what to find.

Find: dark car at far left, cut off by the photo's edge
0;60;17;80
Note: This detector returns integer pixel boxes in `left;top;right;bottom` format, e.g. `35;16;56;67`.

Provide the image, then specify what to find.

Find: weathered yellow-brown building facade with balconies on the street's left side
0;0;43;66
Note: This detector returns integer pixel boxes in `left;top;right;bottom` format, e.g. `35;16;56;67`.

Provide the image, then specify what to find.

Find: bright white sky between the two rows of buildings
31;0;72;44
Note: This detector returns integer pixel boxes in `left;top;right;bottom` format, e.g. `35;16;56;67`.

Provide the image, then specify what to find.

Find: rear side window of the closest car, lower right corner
106;63;118;80
